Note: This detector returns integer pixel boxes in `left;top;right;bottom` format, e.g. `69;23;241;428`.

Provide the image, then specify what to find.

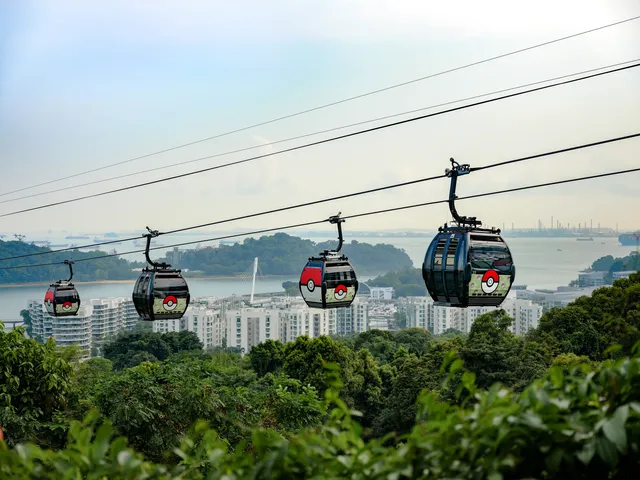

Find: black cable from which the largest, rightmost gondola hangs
0;132;640;261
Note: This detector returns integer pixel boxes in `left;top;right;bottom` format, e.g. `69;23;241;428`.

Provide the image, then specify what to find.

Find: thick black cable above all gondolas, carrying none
0;59;640;218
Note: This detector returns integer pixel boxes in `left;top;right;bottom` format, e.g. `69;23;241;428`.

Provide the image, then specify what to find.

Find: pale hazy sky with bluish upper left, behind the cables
0;0;640;240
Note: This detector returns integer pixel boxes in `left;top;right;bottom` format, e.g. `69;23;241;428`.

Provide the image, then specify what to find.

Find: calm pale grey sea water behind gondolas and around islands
0;237;634;328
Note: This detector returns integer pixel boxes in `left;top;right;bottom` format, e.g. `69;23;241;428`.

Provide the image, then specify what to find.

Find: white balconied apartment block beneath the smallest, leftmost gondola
28;298;140;356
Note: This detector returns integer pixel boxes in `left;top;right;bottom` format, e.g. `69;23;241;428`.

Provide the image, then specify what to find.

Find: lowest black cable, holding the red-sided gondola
0;167;640;270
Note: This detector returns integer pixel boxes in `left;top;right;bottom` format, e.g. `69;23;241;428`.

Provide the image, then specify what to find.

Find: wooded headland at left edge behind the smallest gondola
0;240;138;283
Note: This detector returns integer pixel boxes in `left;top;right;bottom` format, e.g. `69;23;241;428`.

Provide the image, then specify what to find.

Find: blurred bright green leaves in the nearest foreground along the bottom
0;345;640;480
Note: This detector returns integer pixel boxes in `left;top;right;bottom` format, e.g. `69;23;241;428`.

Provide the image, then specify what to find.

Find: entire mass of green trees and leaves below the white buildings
0;273;640;480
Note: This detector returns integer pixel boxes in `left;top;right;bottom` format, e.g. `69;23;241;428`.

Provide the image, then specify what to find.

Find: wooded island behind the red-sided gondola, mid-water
167;233;413;278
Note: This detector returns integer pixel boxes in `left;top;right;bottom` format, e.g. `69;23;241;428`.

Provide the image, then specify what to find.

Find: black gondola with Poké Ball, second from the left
132;227;191;322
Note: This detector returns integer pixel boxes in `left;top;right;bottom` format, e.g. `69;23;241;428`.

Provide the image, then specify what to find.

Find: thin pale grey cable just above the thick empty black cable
0;58;640;204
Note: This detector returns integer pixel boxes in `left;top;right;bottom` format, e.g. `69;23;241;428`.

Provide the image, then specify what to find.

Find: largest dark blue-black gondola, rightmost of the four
422;158;516;308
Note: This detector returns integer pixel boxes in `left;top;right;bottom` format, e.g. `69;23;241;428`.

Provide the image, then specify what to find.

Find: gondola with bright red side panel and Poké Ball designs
299;213;358;308
